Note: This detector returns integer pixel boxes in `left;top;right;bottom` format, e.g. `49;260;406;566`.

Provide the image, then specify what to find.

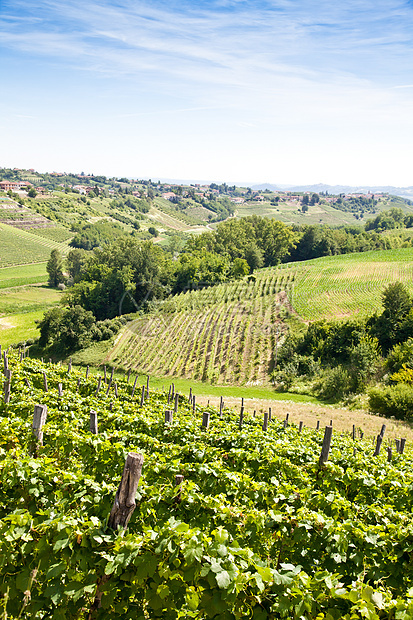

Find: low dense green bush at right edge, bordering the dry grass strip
369;383;413;420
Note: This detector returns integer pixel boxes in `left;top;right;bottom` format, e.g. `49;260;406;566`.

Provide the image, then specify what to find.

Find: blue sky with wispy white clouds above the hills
0;0;413;185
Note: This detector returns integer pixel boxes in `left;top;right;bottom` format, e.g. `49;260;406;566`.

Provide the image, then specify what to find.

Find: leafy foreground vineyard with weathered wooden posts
0;353;413;620
